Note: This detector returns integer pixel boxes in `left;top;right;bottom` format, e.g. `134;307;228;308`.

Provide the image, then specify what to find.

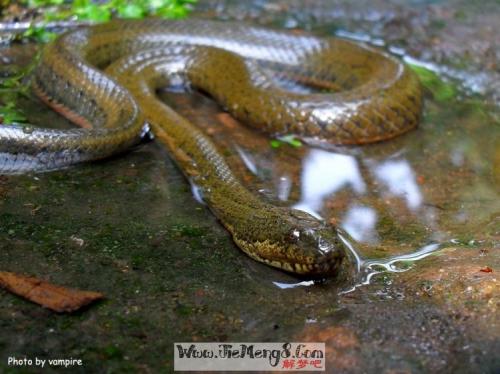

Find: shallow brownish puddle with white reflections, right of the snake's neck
162;77;500;280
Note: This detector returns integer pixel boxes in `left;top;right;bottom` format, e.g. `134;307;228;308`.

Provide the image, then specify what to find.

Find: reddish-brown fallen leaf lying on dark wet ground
0;271;104;313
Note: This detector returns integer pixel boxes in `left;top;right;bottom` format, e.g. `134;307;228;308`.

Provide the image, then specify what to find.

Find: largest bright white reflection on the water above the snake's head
293;149;366;217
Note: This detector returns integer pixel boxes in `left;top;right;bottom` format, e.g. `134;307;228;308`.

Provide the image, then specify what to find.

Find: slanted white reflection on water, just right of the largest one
374;160;422;210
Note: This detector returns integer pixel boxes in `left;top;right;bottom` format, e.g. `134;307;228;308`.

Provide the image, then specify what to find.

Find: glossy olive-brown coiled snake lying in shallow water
0;18;422;278
